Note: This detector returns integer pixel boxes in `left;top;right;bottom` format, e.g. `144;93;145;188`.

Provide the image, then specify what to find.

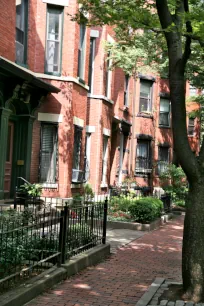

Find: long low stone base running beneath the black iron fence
0;244;110;306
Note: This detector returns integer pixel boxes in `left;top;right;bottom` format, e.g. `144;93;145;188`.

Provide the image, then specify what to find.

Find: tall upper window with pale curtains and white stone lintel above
45;6;63;75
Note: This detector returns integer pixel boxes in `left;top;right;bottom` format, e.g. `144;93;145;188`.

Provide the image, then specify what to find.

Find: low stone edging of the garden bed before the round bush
107;213;174;231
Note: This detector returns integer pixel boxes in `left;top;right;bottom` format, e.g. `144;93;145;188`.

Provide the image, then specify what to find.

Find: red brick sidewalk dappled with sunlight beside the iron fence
27;217;183;306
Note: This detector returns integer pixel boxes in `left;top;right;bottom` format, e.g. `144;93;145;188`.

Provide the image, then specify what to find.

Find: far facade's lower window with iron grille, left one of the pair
136;140;151;172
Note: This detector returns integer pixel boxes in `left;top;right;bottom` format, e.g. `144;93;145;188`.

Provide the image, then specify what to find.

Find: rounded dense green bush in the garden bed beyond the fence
129;197;163;223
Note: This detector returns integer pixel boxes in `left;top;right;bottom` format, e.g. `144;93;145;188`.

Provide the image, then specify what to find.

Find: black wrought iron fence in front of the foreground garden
0;200;108;291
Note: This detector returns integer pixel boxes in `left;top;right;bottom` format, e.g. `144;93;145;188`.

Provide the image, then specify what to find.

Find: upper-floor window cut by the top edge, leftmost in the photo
16;0;28;64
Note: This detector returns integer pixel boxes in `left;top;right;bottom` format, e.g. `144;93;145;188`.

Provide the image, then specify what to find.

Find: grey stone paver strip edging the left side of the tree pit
136;277;165;306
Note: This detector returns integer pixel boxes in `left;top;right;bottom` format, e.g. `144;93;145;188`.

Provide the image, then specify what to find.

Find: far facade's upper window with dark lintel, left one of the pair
140;80;153;112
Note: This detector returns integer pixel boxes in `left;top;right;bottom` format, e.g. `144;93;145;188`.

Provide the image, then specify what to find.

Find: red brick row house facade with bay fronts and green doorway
0;0;199;199
